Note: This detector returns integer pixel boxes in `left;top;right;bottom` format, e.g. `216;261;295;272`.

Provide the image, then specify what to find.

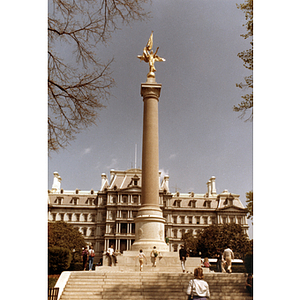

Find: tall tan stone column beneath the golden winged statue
131;78;169;252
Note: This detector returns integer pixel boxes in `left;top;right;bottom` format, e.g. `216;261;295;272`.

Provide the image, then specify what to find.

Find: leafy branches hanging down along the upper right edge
233;0;253;120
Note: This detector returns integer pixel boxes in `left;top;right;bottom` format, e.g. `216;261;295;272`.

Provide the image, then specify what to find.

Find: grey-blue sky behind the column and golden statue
48;0;253;236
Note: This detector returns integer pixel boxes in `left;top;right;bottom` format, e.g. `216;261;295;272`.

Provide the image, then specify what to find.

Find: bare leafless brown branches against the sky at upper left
48;0;149;151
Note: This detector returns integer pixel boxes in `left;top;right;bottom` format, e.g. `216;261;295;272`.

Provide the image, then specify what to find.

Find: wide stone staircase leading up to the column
59;271;253;300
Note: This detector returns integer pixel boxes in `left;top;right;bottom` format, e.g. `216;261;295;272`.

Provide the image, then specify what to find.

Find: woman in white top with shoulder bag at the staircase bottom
186;267;210;300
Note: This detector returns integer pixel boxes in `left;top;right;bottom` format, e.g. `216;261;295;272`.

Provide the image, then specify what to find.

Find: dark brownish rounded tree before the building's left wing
48;221;86;261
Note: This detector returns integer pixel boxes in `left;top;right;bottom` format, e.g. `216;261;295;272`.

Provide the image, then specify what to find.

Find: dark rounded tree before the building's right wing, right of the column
182;224;252;258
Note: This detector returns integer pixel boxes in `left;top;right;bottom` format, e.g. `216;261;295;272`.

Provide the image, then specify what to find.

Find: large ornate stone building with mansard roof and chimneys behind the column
48;169;249;257
